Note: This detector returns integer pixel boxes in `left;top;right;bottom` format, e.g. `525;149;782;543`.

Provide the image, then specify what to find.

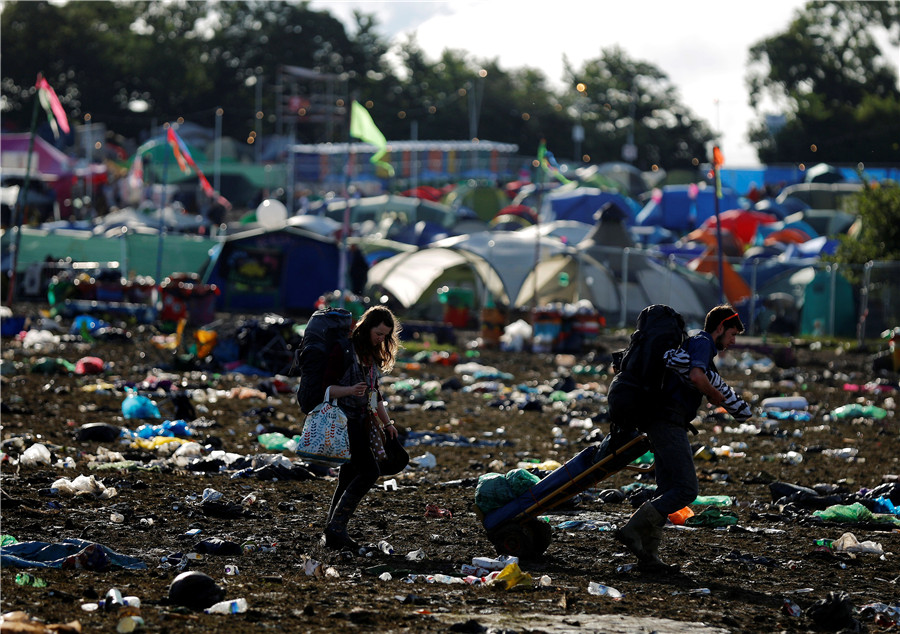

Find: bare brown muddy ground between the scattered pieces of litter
0;312;900;632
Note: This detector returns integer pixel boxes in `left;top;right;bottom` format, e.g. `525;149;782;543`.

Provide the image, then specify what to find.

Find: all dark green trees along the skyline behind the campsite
0;0;900;170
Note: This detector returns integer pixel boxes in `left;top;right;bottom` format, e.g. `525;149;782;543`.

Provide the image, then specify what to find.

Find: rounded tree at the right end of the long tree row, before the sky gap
563;47;713;170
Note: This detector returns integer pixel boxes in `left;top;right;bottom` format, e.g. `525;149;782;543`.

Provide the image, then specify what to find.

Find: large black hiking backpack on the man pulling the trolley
607;304;687;428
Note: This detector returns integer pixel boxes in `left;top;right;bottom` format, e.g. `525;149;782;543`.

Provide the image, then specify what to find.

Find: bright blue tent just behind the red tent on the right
635;185;742;234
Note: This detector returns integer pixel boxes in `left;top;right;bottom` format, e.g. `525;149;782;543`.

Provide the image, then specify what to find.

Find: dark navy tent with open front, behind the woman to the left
202;226;340;312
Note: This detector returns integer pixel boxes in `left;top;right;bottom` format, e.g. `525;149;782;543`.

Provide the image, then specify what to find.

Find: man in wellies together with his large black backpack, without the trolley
609;304;750;572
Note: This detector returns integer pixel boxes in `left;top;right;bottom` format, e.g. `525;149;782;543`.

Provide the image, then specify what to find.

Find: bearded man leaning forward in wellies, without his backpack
614;304;744;572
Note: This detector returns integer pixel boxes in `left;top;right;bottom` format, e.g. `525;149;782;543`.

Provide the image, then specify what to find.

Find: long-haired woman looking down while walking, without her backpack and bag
322;306;400;551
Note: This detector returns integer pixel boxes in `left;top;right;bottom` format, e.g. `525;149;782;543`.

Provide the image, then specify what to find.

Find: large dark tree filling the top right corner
747;0;900;163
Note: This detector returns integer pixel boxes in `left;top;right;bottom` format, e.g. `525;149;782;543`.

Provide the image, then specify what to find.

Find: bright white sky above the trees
310;0;805;167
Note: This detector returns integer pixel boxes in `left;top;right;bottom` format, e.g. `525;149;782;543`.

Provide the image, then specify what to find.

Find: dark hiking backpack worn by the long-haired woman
297;308;353;414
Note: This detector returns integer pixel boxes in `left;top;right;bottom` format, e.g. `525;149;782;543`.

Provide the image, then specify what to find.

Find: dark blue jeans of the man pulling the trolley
643;418;699;517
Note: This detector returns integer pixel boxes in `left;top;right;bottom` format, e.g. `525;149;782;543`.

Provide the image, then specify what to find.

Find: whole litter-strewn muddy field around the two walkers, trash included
0;320;900;632
